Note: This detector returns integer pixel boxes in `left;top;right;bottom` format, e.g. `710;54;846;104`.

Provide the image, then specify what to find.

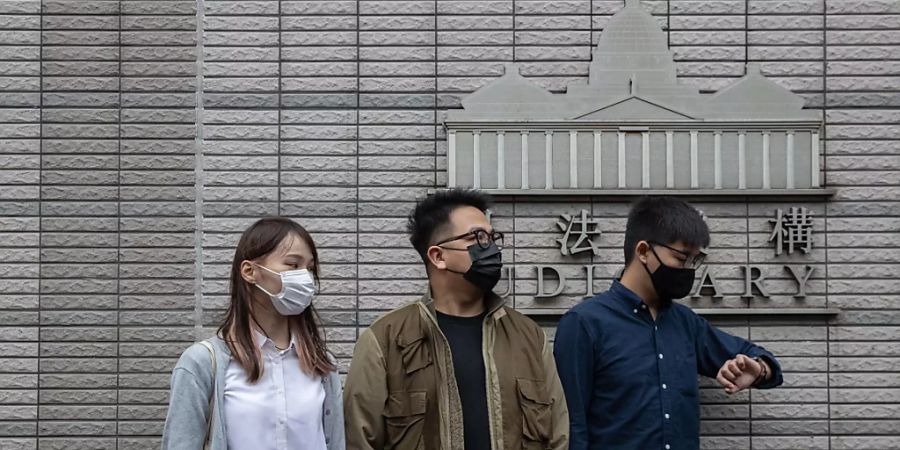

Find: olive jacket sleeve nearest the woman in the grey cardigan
344;330;388;450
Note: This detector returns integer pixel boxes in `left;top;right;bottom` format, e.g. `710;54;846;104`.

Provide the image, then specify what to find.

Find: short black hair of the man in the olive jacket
406;188;491;263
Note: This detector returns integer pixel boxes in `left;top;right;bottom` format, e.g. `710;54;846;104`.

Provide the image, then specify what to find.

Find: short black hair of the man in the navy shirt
625;197;709;265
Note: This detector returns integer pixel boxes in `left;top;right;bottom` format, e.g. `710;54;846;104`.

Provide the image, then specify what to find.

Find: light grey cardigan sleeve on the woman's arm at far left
162;366;211;450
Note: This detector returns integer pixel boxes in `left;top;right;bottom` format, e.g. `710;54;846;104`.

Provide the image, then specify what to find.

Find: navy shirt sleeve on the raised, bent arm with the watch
691;312;784;389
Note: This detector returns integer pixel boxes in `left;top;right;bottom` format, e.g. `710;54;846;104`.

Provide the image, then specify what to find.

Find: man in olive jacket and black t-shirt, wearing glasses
344;189;569;450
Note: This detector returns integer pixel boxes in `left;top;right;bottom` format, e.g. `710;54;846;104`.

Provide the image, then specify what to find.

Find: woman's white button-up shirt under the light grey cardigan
223;330;326;450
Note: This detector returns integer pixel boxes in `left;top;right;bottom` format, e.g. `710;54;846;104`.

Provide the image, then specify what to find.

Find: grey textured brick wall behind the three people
0;0;900;450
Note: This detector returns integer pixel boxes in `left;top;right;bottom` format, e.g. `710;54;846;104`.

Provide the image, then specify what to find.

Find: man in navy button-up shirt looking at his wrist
554;197;782;450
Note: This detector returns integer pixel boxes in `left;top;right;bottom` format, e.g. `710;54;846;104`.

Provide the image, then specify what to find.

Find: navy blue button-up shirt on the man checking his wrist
554;281;782;450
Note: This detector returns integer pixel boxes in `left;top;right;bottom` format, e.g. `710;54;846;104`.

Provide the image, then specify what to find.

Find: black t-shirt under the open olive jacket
437;312;491;450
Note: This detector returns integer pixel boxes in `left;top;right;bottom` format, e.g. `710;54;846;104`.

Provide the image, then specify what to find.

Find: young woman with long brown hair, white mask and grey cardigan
162;217;344;450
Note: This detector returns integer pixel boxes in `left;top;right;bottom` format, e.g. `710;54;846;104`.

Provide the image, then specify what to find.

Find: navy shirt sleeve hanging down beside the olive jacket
553;311;594;450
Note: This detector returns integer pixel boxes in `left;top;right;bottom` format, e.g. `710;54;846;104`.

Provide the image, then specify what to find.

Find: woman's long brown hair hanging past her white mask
219;217;335;383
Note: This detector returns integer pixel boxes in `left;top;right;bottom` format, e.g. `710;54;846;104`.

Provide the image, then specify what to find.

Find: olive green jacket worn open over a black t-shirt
344;295;569;450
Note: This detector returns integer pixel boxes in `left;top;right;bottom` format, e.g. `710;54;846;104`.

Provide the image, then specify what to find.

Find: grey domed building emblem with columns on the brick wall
445;0;823;195
